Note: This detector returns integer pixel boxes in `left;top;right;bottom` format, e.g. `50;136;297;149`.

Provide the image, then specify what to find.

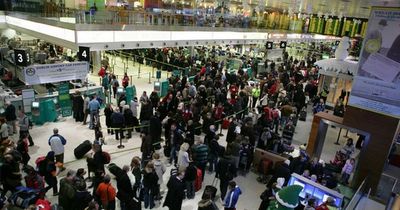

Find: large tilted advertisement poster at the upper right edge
349;7;400;118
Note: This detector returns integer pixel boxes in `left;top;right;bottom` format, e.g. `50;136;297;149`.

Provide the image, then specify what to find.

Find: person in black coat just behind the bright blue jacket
215;153;236;198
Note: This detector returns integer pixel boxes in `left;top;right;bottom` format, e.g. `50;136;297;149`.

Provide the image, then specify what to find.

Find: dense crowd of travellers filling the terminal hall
0;45;354;210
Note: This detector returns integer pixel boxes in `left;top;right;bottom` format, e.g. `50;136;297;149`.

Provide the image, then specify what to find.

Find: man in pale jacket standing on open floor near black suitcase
49;128;67;171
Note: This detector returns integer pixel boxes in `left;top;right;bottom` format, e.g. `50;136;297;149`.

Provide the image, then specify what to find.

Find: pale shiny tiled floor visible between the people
11;56;394;210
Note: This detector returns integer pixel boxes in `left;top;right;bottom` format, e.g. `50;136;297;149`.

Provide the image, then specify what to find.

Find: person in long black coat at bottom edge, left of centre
163;169;185;210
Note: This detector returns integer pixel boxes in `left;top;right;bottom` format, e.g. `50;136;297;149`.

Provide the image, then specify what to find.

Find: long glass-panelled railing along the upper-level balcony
5;1;305;33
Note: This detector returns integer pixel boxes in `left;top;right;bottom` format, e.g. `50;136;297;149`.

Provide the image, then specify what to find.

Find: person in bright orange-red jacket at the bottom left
96;175;116;210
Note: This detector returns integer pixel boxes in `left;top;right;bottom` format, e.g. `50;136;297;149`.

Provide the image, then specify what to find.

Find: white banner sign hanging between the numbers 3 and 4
24;62;89;85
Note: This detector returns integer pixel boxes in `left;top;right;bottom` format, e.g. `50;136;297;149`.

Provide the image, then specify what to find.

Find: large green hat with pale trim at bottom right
275;185;303;208
